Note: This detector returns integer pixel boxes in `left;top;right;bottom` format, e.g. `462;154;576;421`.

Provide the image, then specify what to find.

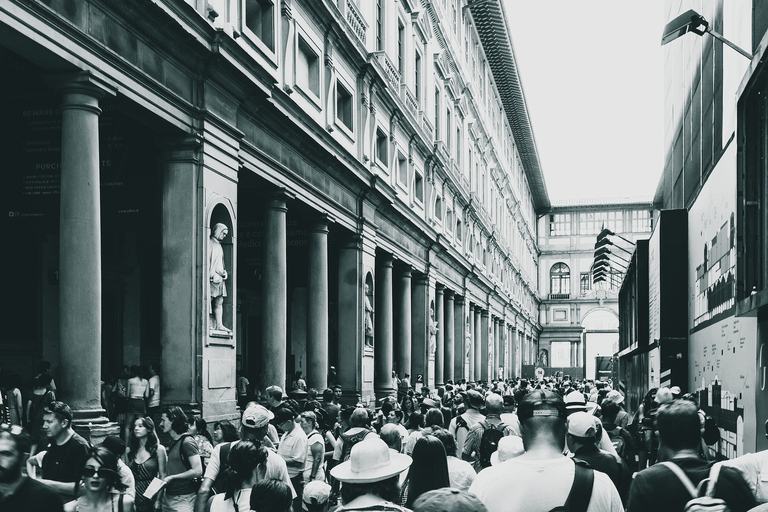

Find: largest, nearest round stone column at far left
56;73;114;428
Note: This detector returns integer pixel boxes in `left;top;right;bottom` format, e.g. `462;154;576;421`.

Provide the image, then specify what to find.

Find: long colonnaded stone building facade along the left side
0;0;550;432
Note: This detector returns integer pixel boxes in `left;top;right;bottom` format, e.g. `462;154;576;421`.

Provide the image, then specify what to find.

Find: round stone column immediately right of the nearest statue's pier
260;193;288;389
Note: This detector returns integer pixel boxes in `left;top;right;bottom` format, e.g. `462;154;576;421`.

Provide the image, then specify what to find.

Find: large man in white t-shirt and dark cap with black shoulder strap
469;390;623;512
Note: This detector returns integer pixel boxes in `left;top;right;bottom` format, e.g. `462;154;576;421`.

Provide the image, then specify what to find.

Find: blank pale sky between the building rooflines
503;0;665;201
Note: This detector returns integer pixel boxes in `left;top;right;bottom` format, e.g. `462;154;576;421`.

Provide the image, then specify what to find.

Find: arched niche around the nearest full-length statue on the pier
205;203;235;338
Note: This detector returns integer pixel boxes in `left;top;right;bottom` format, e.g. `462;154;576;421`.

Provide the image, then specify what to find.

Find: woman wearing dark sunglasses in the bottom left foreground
64;446;134;512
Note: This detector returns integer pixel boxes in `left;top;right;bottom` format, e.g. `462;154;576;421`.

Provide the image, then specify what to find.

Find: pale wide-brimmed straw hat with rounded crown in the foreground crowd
331;438;411;484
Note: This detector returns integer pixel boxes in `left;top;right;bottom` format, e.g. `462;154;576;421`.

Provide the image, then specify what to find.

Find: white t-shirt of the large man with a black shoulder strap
469;457;624;512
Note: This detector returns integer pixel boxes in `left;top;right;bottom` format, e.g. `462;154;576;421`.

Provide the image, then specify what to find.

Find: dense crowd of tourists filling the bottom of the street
0;369;768;512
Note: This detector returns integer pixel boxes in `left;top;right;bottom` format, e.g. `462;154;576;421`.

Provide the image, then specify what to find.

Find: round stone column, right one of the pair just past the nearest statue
307;218;328;390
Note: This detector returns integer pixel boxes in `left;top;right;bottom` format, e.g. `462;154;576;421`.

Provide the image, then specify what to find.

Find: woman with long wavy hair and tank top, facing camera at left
125;416;166;512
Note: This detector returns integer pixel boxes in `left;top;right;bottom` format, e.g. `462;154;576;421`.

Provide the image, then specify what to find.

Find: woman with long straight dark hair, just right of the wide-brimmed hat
400;436;451;508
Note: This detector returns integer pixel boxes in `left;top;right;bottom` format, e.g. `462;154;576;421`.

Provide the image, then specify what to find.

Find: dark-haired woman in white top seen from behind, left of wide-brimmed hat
210;441;267;512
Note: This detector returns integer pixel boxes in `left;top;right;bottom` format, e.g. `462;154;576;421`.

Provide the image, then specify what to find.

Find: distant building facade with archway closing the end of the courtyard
536;198;654;379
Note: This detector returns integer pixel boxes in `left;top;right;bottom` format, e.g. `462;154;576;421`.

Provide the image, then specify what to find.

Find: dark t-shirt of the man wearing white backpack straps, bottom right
627;458;757;512
